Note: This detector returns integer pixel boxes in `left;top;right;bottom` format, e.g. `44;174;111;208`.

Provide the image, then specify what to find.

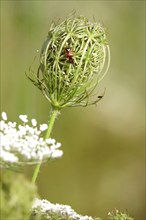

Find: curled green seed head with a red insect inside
28;15;110;109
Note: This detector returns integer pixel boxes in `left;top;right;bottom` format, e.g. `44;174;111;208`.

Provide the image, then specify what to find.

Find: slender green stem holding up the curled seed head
32;107;60;183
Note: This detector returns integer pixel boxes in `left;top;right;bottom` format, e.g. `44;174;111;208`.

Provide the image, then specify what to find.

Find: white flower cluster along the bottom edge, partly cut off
32;199;96;220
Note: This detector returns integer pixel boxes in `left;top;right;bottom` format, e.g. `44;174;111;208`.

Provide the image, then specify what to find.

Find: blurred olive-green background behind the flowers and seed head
1;0;146;220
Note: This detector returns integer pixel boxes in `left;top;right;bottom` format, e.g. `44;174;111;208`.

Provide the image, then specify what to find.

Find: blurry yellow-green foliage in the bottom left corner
0;170;38;220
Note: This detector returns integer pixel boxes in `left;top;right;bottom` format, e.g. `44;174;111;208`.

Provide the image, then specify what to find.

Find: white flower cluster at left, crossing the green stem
0;112;63;166
